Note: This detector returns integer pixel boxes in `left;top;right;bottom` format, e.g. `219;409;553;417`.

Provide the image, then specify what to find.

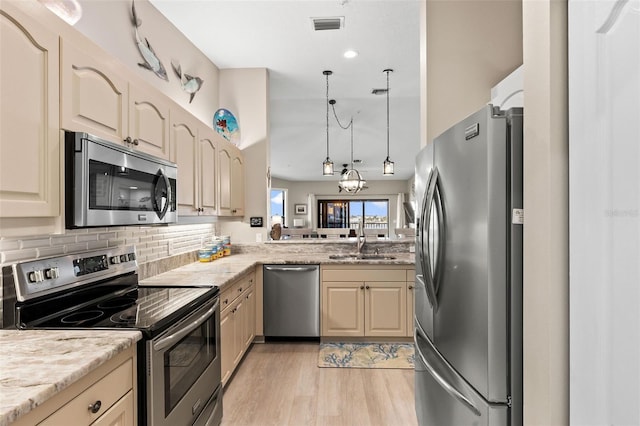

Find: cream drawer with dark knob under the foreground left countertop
40;359;133;426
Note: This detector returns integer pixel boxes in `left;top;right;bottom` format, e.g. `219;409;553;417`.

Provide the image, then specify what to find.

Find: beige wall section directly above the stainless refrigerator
421;0;522;146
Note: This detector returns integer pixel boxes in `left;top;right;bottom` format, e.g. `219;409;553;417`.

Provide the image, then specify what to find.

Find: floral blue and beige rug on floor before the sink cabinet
318;343;415;369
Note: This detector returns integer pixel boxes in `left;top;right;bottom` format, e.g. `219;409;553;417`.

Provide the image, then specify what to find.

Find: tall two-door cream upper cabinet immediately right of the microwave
170;107;218;216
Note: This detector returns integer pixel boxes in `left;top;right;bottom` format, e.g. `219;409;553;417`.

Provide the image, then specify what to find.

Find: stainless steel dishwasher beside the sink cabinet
263;265;320;338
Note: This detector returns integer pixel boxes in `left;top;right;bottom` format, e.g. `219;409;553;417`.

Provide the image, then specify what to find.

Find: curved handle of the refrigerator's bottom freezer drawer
413;321;482;417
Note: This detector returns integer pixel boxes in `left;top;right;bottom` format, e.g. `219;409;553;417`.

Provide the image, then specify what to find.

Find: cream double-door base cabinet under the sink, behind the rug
320;265;407;337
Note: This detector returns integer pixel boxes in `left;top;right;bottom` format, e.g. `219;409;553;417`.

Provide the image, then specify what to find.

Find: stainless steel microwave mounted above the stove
65;132;178;228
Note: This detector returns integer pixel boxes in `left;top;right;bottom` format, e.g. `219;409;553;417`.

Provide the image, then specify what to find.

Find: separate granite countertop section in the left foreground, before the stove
0;330;142;426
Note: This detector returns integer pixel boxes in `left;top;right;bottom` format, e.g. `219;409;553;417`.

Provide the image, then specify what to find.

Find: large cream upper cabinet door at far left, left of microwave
0;2;60;218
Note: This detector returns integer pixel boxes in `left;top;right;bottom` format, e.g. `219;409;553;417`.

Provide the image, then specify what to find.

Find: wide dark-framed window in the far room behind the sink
318;200;389;236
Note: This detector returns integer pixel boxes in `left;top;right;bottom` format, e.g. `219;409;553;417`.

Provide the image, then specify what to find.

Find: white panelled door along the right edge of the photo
569;0;640;425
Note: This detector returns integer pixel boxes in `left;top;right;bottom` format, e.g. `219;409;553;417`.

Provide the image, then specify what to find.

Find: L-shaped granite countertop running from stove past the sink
140;253;415;291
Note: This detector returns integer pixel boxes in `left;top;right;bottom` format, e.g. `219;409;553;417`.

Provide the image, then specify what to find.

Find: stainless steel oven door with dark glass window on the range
147;297;222;426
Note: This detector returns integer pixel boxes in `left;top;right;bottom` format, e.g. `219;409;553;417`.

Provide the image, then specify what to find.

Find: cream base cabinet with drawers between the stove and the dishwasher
220;273;256;385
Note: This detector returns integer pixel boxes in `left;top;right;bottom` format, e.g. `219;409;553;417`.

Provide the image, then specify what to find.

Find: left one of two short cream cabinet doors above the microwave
60;40;128;141
